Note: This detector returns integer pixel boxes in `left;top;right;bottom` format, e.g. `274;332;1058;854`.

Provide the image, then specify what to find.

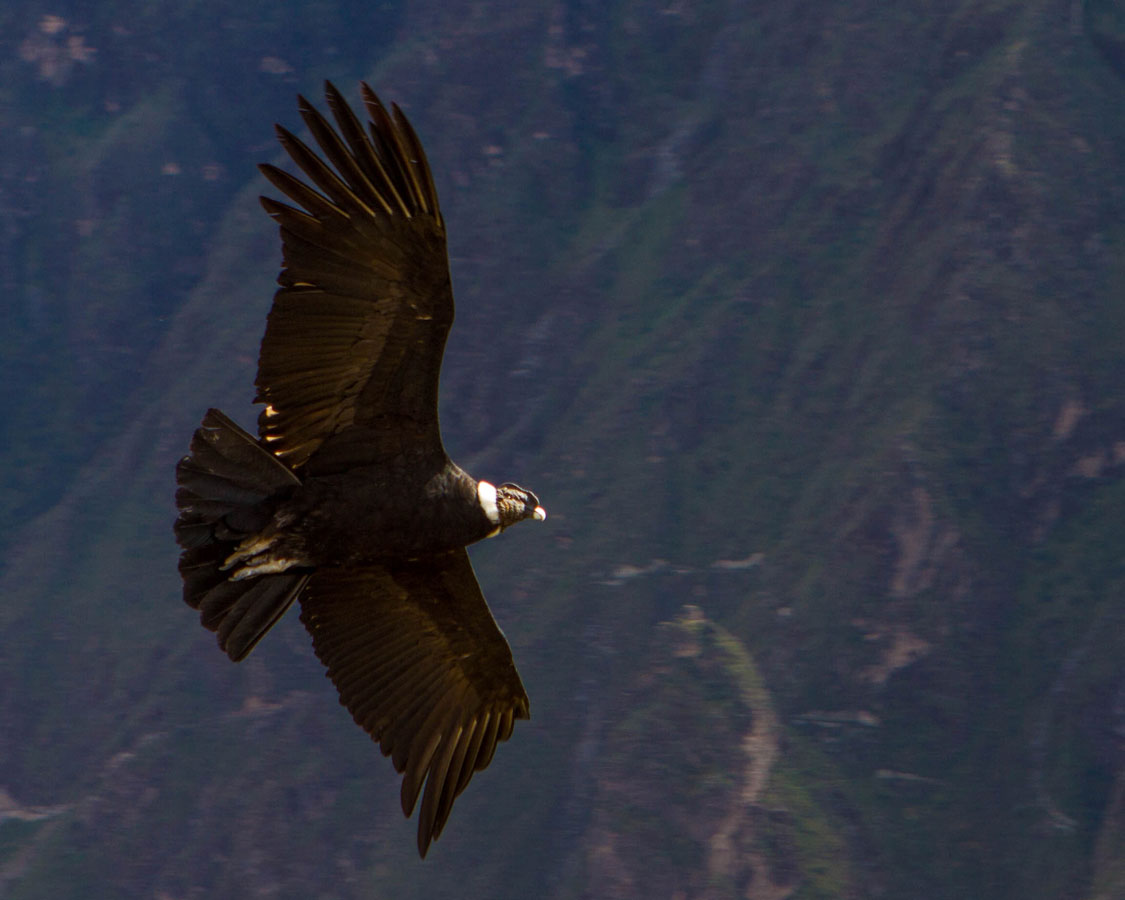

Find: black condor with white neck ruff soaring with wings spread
176;83;547;857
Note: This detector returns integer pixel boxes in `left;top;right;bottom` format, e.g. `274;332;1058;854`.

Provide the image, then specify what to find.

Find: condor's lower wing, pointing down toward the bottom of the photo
300;549;529;856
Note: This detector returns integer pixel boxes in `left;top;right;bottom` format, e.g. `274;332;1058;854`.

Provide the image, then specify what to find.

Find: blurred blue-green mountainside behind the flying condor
0;0;1125;900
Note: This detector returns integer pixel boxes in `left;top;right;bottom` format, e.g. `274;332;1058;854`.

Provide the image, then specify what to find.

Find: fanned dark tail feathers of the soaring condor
176;410;308;662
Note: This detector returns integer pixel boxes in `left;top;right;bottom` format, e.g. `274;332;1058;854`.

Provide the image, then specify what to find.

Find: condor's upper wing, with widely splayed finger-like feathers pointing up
255;83;453;470
